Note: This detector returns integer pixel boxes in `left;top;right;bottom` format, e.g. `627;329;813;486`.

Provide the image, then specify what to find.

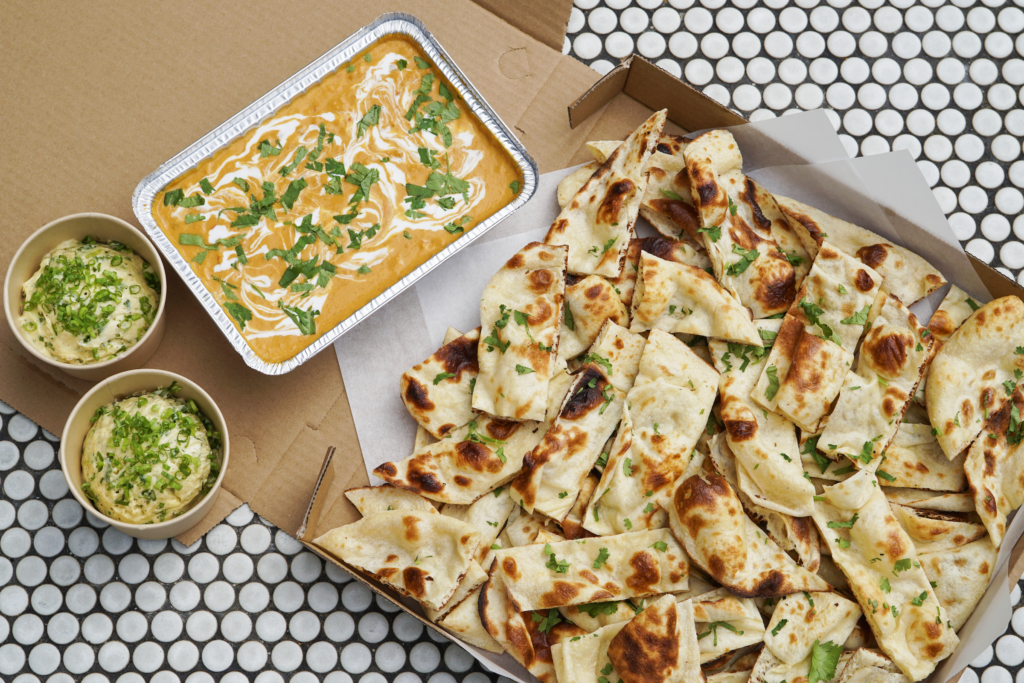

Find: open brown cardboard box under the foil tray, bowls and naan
0;0;1024;679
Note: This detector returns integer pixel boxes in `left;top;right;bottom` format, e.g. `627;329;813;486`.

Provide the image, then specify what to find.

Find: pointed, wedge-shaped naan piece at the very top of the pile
548;110;666;274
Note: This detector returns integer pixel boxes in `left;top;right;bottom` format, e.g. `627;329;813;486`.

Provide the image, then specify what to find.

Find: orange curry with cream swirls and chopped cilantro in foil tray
153;36;521;362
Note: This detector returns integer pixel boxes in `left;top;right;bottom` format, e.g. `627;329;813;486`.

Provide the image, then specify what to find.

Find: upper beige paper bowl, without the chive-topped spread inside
3;213;167;382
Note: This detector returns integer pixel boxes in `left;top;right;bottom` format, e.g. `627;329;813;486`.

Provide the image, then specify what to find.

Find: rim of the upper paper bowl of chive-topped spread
3;212;167;377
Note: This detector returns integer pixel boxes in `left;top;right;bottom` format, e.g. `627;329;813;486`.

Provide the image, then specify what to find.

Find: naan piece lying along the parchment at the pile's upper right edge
775;195;946;306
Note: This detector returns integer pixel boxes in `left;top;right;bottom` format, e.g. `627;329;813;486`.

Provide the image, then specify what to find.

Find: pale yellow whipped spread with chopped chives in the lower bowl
82;384;220;524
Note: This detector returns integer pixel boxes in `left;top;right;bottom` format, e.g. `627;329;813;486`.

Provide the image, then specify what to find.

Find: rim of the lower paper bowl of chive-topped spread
57;368;230;531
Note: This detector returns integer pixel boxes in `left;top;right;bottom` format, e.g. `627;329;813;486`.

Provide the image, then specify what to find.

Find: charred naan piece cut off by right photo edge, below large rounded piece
964;388;1024;549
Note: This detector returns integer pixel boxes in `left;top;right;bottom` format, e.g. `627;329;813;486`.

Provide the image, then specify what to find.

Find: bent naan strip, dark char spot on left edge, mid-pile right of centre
708;321;814;517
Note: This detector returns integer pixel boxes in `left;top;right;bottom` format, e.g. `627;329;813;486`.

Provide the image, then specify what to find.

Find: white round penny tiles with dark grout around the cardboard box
0;0;1024;683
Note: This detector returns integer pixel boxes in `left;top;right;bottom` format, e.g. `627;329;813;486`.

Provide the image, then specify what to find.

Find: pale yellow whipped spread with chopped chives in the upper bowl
20;238;161;365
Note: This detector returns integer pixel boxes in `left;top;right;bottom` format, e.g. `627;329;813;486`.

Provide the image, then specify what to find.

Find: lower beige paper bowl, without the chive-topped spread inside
60;370;230;540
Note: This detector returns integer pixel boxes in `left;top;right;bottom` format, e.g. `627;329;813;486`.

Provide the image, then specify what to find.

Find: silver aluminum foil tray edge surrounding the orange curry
132;12;538;375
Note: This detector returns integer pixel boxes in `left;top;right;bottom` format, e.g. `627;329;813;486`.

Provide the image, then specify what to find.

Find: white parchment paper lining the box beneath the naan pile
335;112;1011;681
